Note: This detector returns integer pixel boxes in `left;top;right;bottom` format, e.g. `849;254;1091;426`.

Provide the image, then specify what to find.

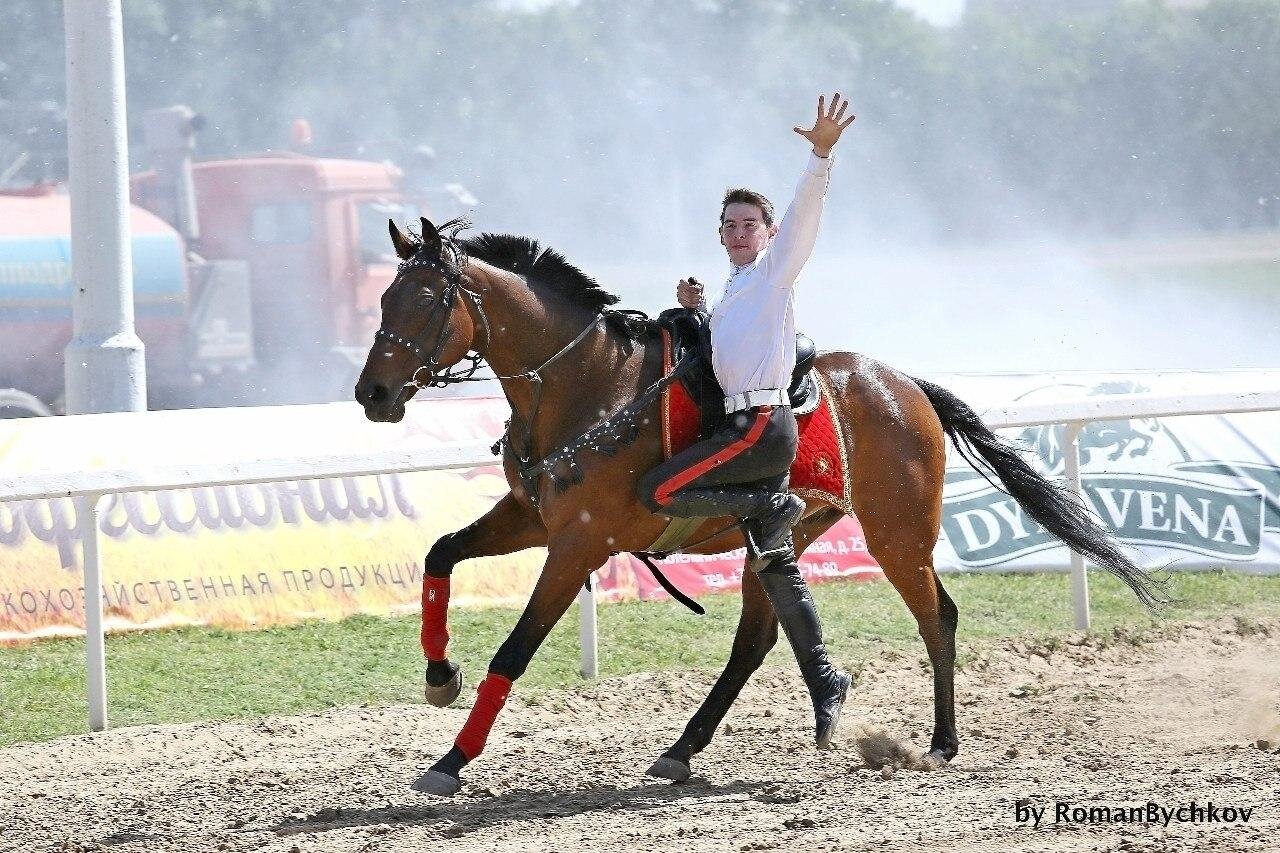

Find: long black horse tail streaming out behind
913;377;1169;610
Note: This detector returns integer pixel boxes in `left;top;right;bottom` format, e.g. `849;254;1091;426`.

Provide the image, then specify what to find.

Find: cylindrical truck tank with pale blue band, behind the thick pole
0;187;188;412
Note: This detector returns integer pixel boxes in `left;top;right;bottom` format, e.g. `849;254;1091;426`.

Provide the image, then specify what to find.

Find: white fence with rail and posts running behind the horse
0;391;1280;731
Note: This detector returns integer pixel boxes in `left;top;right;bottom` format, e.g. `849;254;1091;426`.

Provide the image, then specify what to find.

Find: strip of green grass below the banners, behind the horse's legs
0;573;1280;745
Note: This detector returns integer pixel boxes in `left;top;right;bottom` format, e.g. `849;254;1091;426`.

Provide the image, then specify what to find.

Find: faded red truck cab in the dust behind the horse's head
133;152;417;402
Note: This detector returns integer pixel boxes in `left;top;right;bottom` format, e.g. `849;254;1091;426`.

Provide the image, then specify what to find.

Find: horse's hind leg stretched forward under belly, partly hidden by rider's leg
649;508;842;781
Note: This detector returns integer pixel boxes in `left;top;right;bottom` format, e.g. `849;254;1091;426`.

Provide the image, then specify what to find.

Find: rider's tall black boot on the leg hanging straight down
756;555;854;749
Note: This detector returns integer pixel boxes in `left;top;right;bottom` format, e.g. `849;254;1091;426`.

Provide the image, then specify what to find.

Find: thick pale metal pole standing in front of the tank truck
63;0;147;414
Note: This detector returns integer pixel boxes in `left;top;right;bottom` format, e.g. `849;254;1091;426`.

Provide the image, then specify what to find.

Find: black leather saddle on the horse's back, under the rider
657;309;822;438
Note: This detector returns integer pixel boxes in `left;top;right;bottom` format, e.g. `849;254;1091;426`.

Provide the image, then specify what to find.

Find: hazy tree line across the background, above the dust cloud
0;0;1280;254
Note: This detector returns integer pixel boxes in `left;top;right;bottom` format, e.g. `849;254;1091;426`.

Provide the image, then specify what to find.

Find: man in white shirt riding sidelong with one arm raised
637;92;854;748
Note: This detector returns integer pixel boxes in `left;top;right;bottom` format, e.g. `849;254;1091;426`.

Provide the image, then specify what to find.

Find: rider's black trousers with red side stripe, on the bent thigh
636;406;799;507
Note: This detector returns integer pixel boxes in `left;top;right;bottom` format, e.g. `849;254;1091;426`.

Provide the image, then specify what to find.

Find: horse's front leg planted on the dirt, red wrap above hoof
413;540;608;795
